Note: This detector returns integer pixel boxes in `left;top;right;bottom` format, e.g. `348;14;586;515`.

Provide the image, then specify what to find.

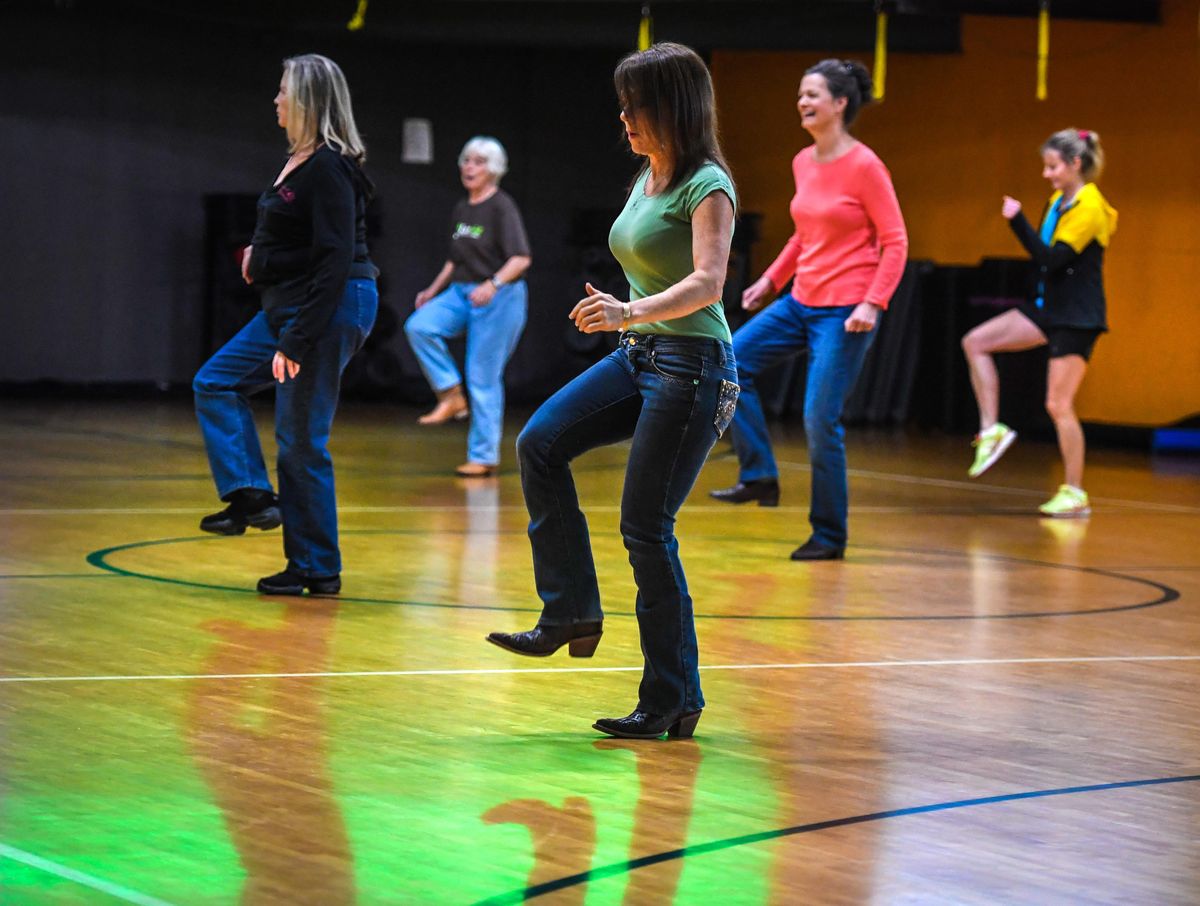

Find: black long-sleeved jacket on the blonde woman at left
248;145;378;364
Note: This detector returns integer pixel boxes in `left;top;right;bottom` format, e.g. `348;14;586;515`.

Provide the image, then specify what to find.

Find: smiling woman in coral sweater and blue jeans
712;60;908;560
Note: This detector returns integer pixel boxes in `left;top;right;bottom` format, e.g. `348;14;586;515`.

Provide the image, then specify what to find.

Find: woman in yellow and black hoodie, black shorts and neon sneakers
962;128;1117;516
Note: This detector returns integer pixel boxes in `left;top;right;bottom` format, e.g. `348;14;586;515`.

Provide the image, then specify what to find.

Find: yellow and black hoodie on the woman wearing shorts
1008;182;1117;330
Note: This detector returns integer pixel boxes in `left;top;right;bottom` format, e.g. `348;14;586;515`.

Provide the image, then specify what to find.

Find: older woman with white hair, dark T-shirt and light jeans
404;136;532;478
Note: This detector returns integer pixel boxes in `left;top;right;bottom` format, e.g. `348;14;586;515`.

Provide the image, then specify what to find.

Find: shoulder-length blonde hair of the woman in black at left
283;54;367;166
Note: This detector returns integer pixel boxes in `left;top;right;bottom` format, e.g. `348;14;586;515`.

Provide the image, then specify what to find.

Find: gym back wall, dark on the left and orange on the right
0;0;1180;432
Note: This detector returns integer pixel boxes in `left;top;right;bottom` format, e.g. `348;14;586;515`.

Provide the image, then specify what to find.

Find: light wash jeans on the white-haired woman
404;280;528;466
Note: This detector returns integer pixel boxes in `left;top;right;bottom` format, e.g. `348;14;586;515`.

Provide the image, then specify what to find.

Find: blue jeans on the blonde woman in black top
192;280;379;577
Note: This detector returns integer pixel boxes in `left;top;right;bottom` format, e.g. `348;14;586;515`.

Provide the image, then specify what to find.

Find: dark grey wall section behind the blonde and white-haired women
0;6;635;392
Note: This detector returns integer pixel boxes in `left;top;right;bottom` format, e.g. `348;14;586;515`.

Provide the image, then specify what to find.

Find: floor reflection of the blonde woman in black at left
187;599;355;906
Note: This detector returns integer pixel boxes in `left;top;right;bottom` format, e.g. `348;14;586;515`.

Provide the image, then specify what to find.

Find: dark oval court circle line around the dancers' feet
86;529;1180;623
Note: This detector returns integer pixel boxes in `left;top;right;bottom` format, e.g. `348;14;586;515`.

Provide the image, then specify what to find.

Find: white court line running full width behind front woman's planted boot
0;654;1200;683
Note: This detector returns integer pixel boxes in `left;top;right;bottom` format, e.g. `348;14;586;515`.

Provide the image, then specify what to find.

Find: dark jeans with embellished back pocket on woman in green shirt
517;334;737;714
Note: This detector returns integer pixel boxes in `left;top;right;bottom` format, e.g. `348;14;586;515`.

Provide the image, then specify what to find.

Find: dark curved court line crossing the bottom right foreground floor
473;774;1200;906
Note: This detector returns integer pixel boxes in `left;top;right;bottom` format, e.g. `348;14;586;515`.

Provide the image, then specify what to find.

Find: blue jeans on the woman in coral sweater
731;294;882;550
